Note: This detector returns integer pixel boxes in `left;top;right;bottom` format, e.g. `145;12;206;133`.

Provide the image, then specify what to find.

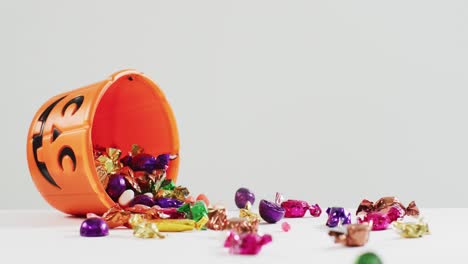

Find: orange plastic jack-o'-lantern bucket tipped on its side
27;70;180;215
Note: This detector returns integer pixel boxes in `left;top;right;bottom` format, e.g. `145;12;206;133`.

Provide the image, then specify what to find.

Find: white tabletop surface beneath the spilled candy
0;208;462;264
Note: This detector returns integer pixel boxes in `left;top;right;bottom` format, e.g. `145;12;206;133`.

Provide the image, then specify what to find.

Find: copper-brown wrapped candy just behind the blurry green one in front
328;223;371;247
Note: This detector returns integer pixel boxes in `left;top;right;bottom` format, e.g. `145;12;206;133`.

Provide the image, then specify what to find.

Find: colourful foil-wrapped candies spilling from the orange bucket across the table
80;145;429;255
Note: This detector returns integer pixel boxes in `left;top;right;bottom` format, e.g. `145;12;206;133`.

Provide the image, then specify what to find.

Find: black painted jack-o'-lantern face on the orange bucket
32;95;84;189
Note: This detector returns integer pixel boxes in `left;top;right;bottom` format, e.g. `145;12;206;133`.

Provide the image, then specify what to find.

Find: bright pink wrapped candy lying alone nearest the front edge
224;231;272;255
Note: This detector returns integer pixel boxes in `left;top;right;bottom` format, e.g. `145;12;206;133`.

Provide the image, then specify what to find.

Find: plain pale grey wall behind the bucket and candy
0;0;468;209
